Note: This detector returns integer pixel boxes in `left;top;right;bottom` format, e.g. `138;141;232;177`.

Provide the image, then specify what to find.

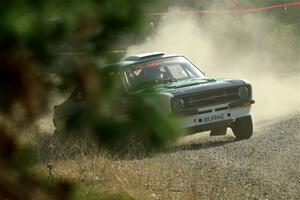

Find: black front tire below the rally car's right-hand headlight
231;116;253;140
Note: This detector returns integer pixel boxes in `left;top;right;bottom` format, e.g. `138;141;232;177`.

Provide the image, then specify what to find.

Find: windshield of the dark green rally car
125;57;205;87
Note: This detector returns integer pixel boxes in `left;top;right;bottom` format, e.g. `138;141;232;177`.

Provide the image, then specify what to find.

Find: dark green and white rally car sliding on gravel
54;53;254;139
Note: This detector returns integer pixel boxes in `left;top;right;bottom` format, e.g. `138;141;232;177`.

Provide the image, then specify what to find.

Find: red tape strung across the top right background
148;2;300;16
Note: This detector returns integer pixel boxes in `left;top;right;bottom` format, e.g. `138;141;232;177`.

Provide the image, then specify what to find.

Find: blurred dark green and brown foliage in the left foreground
0;0;178;199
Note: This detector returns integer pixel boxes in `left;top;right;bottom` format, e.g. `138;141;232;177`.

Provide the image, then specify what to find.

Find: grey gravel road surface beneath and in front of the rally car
102;115;300;199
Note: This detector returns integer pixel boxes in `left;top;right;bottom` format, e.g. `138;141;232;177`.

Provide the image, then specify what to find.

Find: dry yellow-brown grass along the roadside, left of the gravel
28;134;211;199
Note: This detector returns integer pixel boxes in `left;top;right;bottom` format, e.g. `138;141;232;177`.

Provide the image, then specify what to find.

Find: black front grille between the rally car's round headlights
175;87;240;109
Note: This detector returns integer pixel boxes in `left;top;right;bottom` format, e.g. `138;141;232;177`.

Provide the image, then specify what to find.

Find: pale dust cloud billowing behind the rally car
127;9;300;121
